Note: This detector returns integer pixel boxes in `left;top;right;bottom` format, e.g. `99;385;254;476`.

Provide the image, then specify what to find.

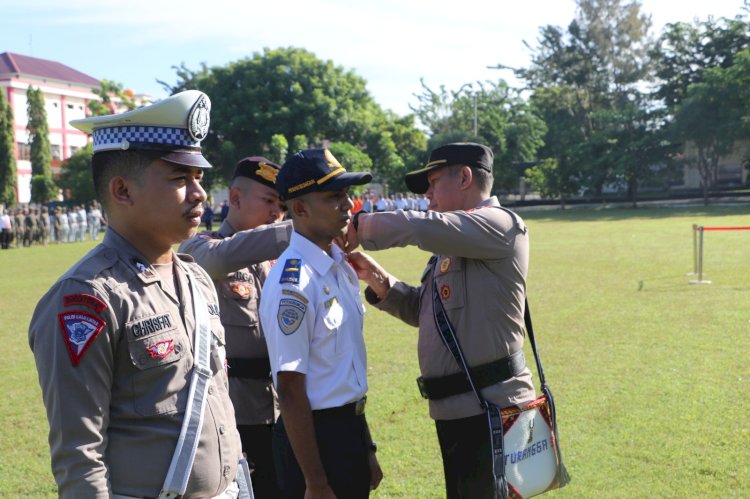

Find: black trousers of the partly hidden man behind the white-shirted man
237;424;280;499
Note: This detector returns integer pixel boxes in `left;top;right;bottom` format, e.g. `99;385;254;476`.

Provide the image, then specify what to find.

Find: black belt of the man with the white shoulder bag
417;350;526;400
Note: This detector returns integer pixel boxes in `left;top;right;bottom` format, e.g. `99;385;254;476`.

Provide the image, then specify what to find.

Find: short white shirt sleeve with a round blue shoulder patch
261;284;315;376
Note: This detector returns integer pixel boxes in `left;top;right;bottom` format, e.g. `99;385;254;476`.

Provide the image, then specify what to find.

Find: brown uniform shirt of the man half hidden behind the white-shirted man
180;220;292;425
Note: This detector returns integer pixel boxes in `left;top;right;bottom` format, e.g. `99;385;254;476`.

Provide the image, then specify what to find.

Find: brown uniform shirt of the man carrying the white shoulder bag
359;197;534;419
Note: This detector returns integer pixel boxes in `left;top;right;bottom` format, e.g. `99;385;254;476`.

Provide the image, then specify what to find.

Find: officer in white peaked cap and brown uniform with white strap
29;90;241;499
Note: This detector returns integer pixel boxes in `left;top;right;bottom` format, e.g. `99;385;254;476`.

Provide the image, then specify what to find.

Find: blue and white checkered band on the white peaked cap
93;125;201;152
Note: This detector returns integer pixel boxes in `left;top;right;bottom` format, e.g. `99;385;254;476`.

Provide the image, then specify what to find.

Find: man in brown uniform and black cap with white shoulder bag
348;143;534;498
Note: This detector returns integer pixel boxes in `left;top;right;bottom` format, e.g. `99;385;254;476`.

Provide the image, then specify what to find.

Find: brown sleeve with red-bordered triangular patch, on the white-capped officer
29;280;118;498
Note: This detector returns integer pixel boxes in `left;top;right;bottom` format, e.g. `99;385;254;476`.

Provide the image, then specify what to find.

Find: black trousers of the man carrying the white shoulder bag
435;414;495;499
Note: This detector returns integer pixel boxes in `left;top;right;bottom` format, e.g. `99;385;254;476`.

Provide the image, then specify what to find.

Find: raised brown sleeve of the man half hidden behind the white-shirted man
180;221;292;279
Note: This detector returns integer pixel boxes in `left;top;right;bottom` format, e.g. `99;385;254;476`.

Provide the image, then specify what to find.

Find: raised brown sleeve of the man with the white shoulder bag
358;207;519;260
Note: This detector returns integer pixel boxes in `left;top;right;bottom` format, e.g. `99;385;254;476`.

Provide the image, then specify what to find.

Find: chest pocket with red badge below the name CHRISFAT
126;315;190;416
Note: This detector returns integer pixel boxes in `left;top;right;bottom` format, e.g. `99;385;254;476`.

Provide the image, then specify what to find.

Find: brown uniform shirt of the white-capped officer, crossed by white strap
29;229;241;498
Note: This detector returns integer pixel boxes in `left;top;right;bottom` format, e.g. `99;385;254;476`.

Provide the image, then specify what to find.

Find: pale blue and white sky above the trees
0;0;744;115
